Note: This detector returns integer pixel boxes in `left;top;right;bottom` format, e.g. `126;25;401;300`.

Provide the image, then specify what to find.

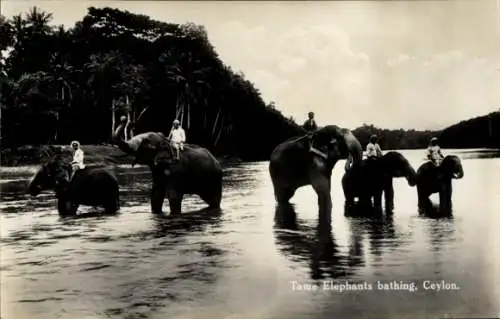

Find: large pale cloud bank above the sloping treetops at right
209;17;500;129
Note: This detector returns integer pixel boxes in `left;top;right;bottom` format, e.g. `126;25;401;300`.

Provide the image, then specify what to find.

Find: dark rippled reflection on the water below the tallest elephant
274;204;364;279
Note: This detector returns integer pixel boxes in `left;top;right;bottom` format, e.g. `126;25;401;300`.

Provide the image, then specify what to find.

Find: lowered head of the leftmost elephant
28;154;72;196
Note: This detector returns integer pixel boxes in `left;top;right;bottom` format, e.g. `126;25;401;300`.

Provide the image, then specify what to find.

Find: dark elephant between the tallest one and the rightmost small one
342;151;417;213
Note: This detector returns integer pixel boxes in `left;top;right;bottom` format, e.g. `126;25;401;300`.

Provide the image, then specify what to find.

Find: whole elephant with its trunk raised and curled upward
114;125;222;214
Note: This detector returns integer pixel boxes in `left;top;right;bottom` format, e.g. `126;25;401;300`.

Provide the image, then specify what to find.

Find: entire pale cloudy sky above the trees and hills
1;0;500;129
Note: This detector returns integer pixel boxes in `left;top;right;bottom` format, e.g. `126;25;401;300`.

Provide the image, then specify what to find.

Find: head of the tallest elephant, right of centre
309;125;363;170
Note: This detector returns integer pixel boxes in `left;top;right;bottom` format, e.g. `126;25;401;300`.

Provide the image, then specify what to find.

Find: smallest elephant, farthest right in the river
417;155;464;214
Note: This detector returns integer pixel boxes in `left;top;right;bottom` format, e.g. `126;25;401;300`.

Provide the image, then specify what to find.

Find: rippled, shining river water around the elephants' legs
0;150;500;319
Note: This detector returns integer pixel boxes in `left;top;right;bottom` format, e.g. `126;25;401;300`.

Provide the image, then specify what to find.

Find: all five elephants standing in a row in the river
28;125;464;220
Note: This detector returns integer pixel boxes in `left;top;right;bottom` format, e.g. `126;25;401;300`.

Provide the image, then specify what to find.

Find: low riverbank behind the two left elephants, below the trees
0;144;241;167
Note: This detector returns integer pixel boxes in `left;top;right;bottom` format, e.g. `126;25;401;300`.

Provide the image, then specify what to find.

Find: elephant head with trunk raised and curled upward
113;124;175;167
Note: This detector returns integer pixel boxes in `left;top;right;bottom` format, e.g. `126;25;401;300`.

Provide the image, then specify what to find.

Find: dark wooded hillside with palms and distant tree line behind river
0;7;500;164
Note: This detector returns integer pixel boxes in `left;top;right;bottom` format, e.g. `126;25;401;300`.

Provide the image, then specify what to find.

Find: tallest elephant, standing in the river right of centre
269;125;363;225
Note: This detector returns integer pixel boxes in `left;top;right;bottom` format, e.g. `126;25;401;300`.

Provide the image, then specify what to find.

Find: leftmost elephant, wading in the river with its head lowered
28;150;120;216
